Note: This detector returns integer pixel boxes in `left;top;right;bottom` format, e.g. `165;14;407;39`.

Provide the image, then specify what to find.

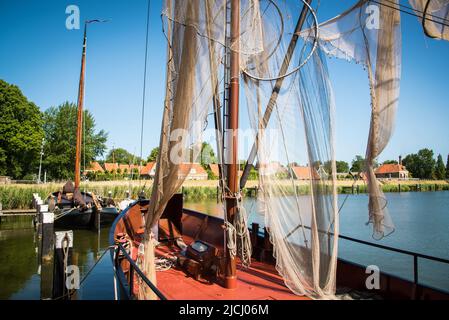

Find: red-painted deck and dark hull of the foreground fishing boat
109;194;449;300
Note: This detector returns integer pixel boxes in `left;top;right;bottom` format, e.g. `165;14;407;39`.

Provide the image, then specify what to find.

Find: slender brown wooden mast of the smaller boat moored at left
75;22;87;189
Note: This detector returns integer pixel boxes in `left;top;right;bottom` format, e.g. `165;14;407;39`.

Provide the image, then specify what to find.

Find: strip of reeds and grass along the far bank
0;180;449;210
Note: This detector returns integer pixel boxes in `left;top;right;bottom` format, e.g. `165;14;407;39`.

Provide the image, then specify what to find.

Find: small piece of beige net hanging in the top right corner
409;0;449;40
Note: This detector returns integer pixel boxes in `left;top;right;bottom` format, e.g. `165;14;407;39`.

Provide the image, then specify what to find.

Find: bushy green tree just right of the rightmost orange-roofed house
402;149;435;179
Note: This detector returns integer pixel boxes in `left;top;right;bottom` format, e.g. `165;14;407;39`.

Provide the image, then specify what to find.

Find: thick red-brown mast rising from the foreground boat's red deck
225;0;240;289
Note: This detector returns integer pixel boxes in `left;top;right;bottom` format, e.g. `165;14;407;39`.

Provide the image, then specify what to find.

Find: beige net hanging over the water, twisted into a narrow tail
302;0;401;239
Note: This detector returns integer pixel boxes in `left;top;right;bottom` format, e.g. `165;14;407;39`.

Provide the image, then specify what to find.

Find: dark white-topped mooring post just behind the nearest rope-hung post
40;212;55;300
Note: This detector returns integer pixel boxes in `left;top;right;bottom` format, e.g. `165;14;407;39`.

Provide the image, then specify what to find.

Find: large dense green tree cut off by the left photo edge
0;80;44;179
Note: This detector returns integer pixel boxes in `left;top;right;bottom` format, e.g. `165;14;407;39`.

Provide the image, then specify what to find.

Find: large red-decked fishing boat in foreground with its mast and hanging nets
109;0;449;300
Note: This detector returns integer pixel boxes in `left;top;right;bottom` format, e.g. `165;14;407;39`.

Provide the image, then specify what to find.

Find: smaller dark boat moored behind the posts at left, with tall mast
47;20;118;228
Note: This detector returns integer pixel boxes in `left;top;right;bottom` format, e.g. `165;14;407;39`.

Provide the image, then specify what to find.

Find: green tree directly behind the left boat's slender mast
44;102;107;179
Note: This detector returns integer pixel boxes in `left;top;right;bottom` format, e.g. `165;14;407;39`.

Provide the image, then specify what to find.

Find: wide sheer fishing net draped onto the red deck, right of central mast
242;1;339;298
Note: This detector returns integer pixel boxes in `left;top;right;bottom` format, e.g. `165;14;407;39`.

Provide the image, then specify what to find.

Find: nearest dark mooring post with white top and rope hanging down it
52;231;73;300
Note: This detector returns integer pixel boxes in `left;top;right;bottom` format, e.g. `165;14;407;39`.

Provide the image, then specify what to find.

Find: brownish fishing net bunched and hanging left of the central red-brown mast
140;0;261;299
